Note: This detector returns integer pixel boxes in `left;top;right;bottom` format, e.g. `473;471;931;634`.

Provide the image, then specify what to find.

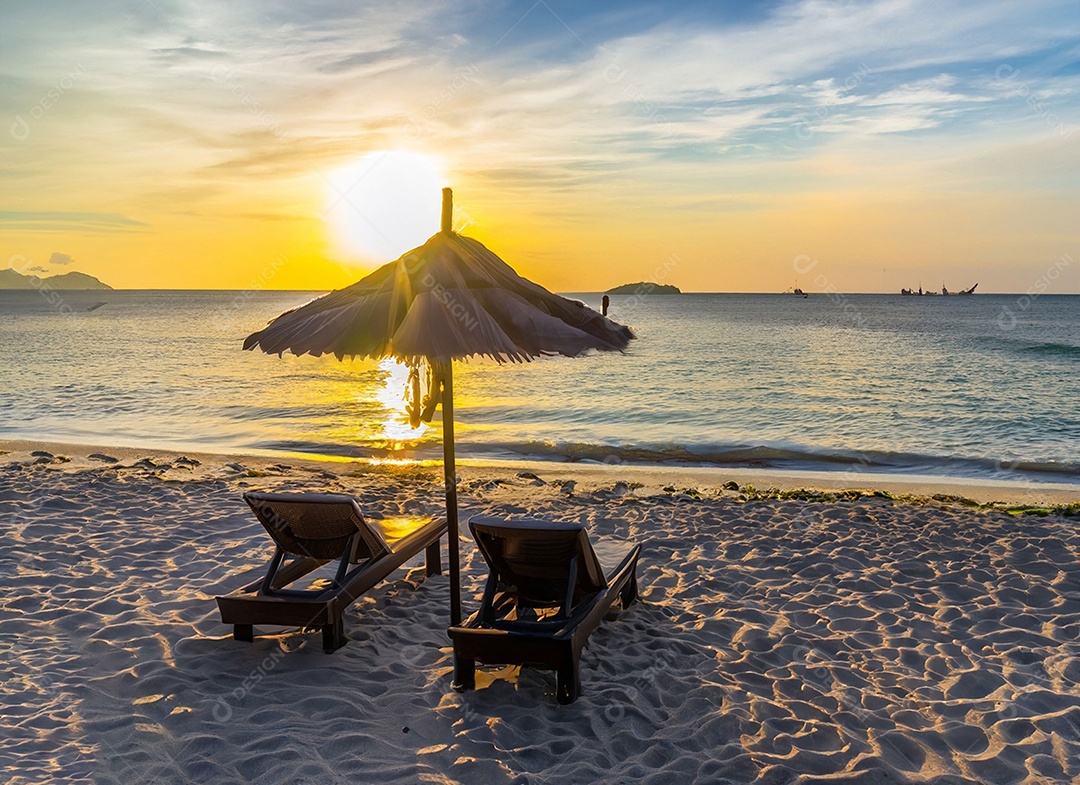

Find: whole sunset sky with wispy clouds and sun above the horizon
0;0;1080;294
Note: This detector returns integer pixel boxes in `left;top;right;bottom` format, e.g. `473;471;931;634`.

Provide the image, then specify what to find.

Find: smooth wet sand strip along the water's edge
0;439;1080;506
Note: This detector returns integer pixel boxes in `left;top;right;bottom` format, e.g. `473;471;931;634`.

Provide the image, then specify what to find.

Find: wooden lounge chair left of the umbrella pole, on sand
217;491;446;652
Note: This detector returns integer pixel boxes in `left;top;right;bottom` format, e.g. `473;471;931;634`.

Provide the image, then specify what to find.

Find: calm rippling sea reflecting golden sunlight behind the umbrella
0;290;1080;483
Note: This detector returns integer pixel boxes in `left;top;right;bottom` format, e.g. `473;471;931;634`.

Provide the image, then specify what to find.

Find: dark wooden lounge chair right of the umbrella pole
449;517;642;704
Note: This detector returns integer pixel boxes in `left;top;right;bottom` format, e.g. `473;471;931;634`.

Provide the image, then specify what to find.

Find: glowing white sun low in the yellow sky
326;150;448;261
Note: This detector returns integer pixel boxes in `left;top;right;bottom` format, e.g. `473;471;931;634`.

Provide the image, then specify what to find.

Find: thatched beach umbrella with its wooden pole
244;188;634;625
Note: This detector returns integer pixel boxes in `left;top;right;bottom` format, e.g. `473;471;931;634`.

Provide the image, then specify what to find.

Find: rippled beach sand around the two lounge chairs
0;444;1080;785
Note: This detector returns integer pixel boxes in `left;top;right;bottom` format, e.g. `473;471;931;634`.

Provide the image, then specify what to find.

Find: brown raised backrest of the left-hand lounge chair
244;491;390;561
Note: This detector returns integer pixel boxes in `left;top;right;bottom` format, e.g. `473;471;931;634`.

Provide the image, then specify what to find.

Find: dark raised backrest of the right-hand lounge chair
469;516;607;613
